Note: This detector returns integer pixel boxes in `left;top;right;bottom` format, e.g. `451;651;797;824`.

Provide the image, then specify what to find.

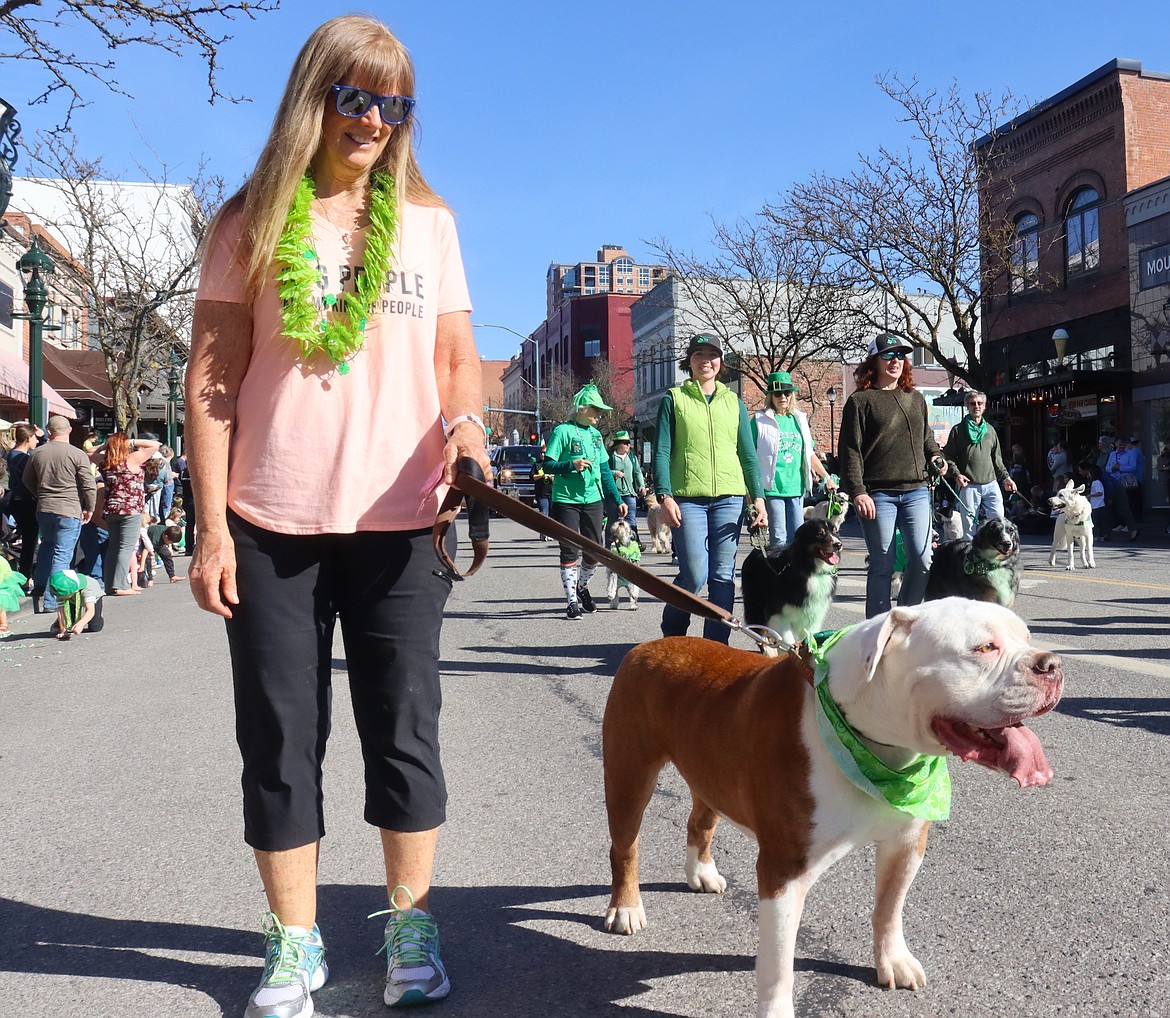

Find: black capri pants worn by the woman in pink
227;511;452;852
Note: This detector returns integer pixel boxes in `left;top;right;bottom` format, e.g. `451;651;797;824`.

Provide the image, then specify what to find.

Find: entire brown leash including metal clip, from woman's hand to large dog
431;456;790;649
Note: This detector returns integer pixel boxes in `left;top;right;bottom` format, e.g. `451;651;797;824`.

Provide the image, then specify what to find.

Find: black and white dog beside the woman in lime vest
739;520;841;655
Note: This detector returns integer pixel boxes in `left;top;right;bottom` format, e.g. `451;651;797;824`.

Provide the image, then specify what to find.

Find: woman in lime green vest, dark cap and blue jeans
654;333;768;644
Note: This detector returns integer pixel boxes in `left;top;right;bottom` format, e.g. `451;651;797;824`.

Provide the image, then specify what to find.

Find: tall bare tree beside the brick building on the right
765;76;1044;388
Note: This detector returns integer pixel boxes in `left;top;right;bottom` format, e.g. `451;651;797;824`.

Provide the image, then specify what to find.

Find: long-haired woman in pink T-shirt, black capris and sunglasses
186;15;490;1018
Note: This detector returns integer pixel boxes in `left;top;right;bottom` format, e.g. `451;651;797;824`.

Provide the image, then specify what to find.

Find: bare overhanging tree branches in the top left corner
0;0;280;128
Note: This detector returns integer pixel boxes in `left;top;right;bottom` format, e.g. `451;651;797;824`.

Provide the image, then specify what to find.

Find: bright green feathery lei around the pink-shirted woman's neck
276;173;398;374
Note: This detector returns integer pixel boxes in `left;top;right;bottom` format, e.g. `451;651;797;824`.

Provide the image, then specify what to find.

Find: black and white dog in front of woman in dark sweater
925;520;1021;608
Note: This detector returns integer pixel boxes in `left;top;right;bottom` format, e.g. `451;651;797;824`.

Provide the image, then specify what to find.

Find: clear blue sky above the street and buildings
0;0;1170;358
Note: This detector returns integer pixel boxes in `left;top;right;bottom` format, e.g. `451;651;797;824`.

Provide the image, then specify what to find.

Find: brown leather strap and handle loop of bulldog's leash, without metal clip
433;458;734;639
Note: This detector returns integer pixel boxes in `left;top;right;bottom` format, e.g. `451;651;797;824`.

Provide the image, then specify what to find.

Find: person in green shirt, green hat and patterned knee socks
544;381;626;619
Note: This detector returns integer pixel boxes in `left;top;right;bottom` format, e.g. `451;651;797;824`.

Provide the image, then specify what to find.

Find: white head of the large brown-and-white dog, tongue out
828;598;1064;787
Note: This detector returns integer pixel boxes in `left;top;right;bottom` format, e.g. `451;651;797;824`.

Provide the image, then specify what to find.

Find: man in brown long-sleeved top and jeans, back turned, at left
23;415;97;612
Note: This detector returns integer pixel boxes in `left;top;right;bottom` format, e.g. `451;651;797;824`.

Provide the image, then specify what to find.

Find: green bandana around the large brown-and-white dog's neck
810;626;951;820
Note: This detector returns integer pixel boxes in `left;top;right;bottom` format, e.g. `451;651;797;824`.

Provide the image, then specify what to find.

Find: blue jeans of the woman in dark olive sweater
861;484;934;619
